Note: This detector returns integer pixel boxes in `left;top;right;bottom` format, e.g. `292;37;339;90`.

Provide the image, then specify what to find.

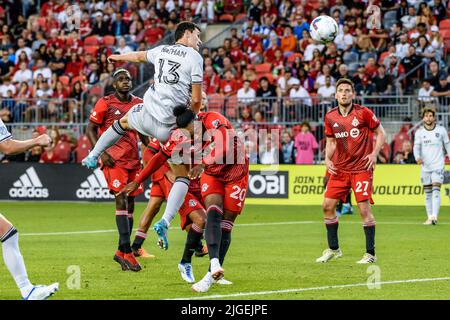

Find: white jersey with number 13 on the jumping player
144;44;203;124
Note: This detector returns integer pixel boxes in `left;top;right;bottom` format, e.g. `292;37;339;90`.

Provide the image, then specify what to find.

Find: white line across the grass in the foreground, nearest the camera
166;277;450;300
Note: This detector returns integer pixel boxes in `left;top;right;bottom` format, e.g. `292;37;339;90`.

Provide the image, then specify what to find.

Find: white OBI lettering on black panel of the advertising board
248;171;289;198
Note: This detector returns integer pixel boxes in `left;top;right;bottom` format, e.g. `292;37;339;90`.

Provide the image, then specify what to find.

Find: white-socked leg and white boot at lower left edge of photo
0;214;59;300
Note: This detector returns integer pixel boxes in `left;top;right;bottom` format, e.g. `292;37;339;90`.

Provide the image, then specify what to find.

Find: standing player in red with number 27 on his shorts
316;78;386;263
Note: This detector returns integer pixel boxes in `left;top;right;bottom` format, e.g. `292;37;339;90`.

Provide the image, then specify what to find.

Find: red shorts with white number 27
325;171;374;204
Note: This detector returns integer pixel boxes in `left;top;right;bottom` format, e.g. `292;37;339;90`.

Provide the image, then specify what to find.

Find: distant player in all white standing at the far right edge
414;108;450;225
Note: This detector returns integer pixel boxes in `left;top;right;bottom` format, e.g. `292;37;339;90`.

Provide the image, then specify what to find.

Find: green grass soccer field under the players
0;202;450;300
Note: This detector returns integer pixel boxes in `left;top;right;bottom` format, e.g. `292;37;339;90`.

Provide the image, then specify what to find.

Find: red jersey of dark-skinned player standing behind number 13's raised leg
89;94;142;169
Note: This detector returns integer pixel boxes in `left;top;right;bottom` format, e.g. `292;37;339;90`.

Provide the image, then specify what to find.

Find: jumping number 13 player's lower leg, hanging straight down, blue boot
153;164;190;250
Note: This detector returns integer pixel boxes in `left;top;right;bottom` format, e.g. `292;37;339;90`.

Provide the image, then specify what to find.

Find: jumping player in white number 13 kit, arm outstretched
82;22;203;250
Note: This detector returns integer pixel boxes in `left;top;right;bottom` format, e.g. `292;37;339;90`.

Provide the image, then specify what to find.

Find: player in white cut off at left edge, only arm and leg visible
0;119;59;300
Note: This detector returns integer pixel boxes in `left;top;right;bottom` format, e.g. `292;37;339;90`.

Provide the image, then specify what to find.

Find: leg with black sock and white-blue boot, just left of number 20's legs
178;208;206;283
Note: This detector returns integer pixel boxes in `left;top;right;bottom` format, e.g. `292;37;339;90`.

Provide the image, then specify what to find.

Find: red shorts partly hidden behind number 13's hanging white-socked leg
150;176;205;230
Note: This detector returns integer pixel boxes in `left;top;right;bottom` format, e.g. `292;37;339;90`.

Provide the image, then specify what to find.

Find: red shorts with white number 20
200;173;248;214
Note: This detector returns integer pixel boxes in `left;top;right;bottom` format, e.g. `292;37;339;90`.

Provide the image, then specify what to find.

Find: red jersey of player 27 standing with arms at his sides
325;104;380;173
